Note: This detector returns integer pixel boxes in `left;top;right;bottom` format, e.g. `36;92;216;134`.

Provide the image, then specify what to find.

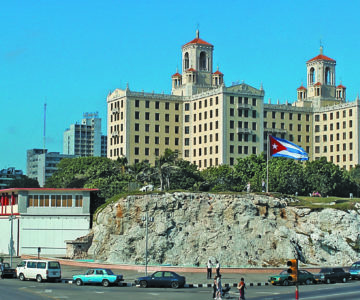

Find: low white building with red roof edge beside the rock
0;188;98;256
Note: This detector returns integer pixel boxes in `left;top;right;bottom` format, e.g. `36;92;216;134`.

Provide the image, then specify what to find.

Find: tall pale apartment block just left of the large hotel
63;112;107;157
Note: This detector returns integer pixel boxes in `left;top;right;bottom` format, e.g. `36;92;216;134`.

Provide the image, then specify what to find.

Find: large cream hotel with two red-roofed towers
107;31;360;169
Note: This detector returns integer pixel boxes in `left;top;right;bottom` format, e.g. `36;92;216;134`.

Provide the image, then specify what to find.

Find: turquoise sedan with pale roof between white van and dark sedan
73;269;124;287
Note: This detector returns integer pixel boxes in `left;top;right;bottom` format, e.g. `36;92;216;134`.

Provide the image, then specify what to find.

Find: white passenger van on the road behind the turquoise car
16;259;61;282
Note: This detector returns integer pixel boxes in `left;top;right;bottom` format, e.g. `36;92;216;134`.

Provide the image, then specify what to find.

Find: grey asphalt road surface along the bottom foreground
0;279;359;300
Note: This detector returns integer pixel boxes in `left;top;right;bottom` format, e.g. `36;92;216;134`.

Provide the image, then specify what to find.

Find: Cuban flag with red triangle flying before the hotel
269;135;309;160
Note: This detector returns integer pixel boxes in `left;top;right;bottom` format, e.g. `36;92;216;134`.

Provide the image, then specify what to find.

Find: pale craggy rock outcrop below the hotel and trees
88;193;360;267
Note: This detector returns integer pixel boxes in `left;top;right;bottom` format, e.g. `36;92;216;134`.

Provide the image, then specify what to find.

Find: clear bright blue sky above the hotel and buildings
0;0;360;174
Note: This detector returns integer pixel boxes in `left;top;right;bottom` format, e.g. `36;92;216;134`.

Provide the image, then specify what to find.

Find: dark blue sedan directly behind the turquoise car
135;271;186;289
